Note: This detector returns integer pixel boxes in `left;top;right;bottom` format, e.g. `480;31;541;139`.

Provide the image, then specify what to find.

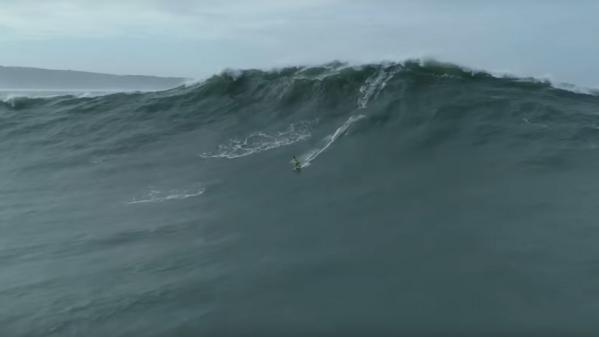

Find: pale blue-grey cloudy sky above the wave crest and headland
0;0;599;88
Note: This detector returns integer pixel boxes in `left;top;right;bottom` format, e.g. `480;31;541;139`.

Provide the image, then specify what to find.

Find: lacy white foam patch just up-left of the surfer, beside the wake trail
200;122;313;159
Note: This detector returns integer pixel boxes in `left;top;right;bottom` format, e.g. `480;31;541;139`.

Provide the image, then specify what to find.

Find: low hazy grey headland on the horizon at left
0;66;187;91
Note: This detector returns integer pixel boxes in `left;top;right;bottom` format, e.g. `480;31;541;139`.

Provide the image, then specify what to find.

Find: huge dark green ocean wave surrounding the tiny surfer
0;61;599;336
